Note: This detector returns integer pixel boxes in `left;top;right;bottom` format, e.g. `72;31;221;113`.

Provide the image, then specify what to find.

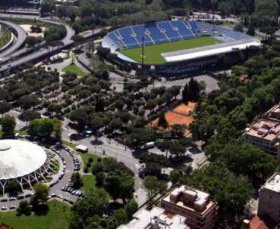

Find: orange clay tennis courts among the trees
150;102;196;136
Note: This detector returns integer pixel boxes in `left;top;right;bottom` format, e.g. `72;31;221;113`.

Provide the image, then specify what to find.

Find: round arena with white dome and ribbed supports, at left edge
0;139;56;195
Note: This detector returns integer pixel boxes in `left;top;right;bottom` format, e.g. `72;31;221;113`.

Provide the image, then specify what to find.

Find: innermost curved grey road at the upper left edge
0;20;26;59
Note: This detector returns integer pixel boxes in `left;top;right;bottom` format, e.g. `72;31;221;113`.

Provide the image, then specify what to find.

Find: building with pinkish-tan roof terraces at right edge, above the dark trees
244;104;280;155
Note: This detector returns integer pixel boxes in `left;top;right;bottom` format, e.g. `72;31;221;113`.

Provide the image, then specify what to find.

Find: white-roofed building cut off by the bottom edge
118;207;190;229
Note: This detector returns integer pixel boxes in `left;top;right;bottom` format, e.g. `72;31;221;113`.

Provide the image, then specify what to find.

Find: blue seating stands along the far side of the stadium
107;20;254;48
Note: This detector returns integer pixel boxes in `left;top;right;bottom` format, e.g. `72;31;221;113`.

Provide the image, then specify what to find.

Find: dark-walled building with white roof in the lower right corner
258;172;280;224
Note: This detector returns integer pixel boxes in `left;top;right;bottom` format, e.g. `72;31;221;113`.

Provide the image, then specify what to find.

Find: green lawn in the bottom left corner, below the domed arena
0;200;70;229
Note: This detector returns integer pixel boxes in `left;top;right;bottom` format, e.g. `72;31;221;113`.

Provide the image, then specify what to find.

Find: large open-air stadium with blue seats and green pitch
102;20;261;72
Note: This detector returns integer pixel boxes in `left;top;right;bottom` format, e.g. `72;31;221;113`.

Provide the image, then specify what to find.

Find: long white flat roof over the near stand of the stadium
162;40;261;62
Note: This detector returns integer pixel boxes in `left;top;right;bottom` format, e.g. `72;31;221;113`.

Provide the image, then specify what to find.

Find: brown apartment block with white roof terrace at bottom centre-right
161;185;218;229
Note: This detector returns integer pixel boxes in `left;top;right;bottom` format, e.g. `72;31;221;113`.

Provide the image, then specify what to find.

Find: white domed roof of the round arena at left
0;140;47;180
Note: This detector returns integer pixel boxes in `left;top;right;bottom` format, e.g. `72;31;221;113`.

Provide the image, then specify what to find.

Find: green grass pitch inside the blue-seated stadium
120;37;220;64
